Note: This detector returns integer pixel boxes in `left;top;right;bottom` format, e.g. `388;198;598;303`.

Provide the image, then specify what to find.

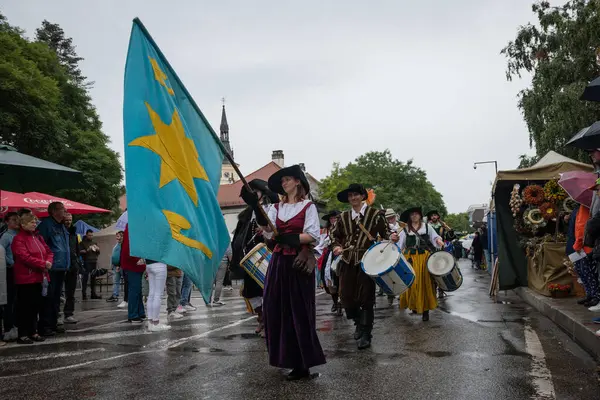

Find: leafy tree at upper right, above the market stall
502;0;600;162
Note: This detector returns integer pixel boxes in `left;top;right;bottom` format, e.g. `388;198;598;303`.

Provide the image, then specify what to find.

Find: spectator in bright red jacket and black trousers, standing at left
11;214;54;344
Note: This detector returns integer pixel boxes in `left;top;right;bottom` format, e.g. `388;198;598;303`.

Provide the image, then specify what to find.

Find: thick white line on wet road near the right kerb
525;325;556;400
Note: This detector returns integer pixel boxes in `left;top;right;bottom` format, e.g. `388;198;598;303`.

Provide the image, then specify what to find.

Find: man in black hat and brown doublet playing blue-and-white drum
331;183;398;349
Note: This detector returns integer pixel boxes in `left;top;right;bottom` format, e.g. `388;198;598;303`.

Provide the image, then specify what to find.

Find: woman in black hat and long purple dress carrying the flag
244;165;325;380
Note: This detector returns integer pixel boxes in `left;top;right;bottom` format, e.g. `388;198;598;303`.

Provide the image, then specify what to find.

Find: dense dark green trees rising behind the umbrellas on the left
0;14;123;226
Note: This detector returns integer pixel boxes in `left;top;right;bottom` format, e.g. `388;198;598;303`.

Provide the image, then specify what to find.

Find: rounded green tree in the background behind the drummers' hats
319;150;446;215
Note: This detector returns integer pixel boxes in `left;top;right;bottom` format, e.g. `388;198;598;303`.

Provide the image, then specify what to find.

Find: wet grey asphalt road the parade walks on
0;264;600;400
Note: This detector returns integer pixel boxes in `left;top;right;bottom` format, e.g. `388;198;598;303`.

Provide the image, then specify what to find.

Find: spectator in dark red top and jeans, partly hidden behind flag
121;225;146;323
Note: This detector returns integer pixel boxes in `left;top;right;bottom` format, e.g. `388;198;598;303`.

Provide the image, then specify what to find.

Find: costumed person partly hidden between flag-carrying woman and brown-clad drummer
315;210;342;315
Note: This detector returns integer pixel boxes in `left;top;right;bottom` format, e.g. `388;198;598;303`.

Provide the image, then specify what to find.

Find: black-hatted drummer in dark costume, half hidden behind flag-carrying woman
230;179;279;337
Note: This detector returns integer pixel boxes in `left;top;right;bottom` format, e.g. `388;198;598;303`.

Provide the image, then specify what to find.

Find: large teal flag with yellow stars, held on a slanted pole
123;18;229;303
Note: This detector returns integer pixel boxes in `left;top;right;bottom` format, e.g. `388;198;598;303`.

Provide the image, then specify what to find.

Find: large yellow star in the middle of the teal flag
129;103;208;206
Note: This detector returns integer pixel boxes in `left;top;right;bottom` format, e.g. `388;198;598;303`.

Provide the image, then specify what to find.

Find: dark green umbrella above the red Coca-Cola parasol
0;144;86;193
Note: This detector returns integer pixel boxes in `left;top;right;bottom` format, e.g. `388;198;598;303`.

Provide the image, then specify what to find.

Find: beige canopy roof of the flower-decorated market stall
494;151;594;189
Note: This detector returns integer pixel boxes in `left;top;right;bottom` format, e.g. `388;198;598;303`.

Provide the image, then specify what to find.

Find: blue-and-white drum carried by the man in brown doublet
360;242;415;295
